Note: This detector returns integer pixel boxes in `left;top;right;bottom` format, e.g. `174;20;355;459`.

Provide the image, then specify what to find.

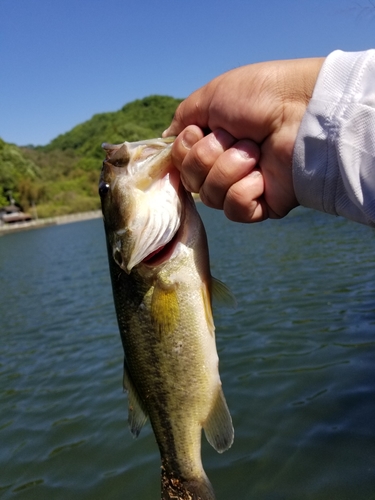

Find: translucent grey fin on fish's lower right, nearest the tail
203;387;234;453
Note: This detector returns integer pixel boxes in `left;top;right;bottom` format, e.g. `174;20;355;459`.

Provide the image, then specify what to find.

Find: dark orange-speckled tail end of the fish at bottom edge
161;466;215;500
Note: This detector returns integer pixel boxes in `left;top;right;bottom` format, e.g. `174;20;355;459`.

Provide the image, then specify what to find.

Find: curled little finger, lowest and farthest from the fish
223;170;268;222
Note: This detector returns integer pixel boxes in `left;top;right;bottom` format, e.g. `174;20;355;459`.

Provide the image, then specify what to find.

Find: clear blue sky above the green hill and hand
0;0;375;145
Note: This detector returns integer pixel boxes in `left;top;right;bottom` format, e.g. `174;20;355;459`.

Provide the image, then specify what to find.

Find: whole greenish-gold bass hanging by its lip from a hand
99;138;234;500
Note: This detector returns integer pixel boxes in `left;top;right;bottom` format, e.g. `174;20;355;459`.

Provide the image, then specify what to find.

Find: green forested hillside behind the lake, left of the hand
0;96;181;217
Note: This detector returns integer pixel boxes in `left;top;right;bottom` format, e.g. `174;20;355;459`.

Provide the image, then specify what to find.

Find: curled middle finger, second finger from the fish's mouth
176;129;236;193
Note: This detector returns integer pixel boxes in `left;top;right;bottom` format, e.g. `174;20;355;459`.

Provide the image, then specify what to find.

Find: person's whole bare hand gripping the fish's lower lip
163;58;324;222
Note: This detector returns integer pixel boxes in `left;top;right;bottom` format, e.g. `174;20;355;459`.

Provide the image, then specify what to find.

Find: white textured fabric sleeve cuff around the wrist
293;50;375;227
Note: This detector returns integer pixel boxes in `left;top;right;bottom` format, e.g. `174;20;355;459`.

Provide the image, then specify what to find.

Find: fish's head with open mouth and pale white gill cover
99;138;182;274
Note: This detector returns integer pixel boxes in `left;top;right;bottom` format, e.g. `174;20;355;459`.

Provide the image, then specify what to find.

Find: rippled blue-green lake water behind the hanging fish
0;205;375;500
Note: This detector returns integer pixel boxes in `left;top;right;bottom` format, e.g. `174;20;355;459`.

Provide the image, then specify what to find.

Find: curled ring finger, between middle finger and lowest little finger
199;139;260;209
